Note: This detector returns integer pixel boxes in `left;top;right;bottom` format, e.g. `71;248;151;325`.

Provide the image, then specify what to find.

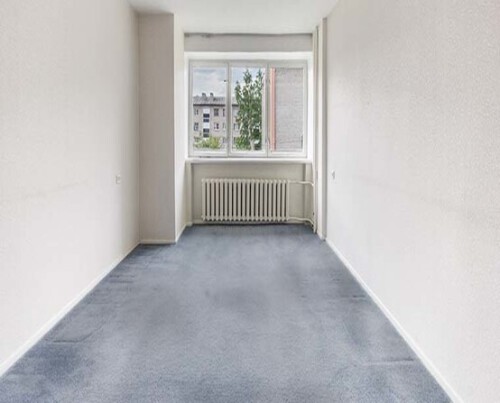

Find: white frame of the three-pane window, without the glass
187;59;309;159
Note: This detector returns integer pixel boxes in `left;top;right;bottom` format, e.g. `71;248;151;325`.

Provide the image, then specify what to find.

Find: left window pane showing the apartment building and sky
191;67;227;153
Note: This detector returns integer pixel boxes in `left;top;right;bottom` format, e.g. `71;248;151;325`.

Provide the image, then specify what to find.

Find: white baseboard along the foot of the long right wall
326;238;463;403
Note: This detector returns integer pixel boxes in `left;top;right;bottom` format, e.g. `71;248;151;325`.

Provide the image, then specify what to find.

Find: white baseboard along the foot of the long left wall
0;245;137;377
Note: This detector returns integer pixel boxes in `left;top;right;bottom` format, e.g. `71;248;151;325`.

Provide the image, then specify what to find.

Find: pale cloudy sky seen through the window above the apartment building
193;67;259;97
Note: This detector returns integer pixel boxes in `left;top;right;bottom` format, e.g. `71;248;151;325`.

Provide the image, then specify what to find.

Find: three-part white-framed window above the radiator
189;61;307;157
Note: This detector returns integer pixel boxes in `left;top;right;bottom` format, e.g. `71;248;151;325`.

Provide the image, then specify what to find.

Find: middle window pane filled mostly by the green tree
231;66;266;153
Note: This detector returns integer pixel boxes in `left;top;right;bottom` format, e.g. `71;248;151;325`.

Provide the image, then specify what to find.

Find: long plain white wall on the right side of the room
327;0;500;403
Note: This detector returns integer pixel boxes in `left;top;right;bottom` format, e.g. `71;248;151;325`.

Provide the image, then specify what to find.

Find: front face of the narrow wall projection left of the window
139;14;176;243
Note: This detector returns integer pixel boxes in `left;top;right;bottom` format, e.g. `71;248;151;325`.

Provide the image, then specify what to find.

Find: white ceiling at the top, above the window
129;0;337;34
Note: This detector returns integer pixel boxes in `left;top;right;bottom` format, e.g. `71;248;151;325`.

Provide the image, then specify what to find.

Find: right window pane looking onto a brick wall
269;67;304;152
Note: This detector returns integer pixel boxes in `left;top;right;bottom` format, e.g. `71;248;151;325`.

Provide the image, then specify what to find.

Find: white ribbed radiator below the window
201;178;291;222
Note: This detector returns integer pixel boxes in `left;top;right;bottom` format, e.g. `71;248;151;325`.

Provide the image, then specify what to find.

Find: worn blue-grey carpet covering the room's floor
0;226;449;403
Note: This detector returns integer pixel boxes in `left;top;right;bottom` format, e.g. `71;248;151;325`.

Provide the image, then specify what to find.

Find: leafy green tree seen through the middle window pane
234;70;264;151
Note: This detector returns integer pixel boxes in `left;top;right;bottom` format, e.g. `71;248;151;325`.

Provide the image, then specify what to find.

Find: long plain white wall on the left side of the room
0;0;139;373
